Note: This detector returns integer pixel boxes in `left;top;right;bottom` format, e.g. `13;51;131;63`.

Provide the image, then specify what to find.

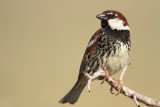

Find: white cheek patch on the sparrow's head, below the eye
108;18;129;30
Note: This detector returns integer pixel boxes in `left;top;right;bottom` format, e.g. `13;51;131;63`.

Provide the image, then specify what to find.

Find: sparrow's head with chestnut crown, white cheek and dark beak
96;10;129;30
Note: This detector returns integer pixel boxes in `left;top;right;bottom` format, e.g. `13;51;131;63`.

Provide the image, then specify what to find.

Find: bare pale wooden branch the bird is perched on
84;69;160;107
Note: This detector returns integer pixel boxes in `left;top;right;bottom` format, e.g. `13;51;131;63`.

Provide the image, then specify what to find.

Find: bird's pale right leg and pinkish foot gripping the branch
116;65;128;95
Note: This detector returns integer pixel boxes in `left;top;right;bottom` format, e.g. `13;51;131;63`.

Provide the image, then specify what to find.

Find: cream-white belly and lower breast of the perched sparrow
106;42;129;75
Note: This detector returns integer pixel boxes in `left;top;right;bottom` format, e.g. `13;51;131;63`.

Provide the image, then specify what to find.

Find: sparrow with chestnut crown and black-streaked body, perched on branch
59;10;131;104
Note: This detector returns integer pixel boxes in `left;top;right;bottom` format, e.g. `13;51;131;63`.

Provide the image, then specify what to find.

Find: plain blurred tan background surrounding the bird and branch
0;0;160;107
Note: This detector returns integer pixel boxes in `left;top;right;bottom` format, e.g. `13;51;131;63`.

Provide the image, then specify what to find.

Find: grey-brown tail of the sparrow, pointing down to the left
59;76;87;104
